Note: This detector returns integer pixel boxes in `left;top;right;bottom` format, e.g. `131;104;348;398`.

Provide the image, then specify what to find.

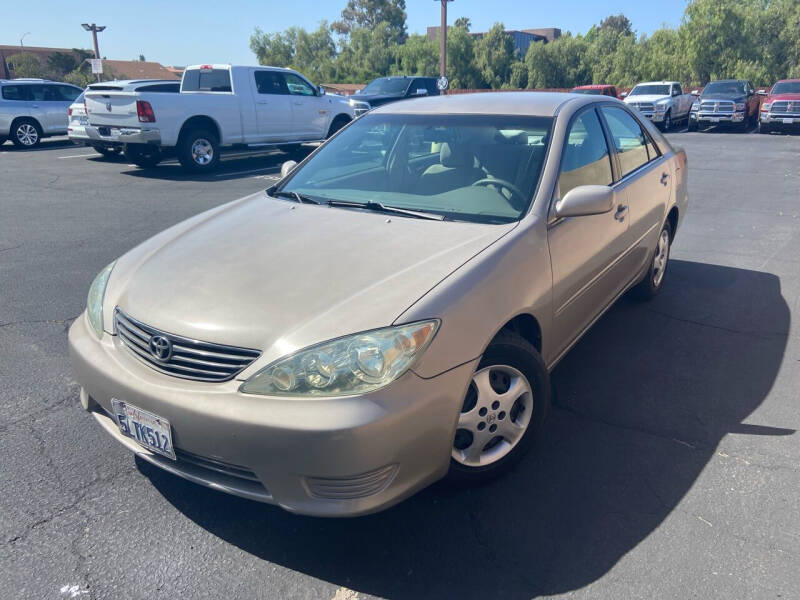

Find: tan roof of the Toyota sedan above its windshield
372;92;580;117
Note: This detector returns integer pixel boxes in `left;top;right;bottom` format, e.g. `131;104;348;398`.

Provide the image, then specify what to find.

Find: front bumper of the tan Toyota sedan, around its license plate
69;314;477;516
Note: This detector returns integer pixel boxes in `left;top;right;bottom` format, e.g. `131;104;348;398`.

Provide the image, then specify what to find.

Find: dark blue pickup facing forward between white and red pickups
689;79;759;131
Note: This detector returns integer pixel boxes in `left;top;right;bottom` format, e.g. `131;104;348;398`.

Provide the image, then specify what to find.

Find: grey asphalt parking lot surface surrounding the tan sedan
0;124;800;600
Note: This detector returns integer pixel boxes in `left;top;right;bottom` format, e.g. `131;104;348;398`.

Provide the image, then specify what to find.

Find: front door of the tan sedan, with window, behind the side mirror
547;108;629;355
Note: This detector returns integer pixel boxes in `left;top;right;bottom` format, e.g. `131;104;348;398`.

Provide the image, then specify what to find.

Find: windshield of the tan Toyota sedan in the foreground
277;113;553;223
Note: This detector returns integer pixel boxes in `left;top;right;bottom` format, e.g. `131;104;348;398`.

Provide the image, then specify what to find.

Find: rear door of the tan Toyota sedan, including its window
600;106;672;276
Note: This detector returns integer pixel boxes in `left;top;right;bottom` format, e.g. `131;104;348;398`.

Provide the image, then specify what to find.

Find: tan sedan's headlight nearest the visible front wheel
239;320;439;397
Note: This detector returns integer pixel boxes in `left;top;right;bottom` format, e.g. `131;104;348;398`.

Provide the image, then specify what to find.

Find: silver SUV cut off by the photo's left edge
0;79;83;148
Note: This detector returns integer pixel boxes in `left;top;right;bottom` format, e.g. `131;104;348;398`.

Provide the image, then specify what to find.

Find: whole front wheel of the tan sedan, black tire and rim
448;331;551;485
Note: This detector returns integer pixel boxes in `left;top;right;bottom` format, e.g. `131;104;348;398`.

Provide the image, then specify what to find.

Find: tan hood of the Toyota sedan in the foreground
104;193;516;360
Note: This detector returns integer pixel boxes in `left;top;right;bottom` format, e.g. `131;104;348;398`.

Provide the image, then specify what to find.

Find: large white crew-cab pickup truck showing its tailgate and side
84;64;362;172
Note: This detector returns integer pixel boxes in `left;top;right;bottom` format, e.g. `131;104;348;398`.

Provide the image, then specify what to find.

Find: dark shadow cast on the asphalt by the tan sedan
137;260;794;599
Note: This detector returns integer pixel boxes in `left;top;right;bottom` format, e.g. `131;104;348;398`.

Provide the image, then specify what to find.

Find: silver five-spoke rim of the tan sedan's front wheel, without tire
452;365;533;467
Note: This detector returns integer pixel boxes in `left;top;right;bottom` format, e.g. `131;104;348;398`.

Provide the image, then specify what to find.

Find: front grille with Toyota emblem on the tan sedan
114;307;261;382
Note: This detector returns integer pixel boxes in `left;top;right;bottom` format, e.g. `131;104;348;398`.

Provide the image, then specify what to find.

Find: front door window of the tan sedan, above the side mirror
558;110;613;198
